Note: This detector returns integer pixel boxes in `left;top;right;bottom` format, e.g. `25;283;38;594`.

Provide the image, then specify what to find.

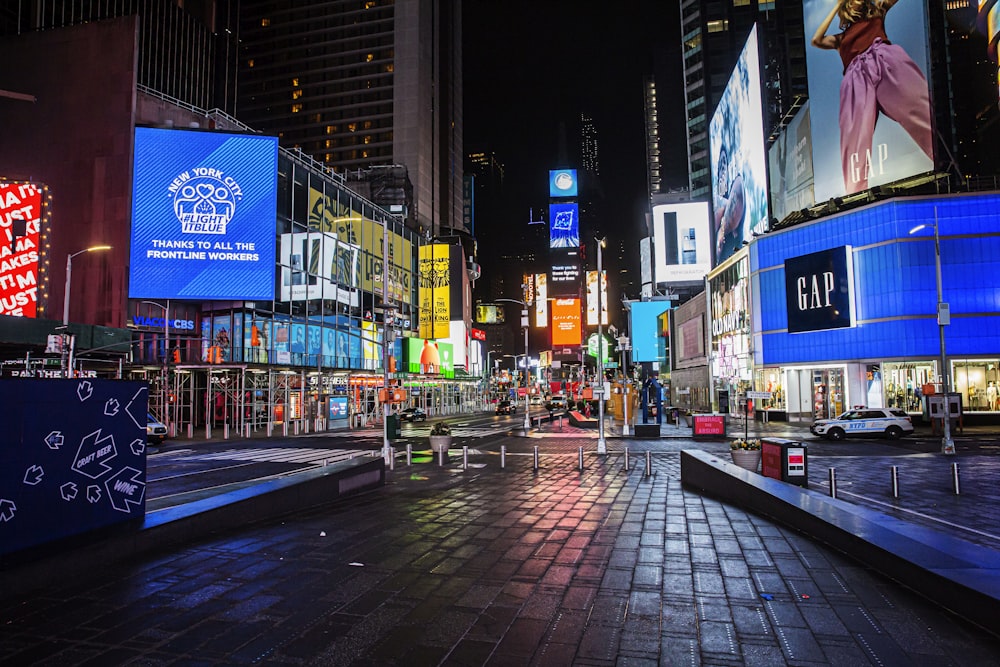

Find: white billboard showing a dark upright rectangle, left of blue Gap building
653;202;712;284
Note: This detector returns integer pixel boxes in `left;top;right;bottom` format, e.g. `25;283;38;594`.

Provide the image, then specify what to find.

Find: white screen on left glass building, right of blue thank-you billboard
280;232;359;306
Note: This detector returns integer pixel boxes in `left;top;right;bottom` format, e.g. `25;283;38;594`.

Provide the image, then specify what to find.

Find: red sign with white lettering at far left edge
0;183;42;317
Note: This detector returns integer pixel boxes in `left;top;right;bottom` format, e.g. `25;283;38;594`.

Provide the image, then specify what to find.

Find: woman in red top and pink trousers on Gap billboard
812;0;934;194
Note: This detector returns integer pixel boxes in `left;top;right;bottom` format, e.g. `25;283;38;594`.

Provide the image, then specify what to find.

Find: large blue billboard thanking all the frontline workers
129;127;278;300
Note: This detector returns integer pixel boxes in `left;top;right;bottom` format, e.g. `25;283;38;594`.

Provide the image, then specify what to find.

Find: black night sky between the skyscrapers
463;0;686;238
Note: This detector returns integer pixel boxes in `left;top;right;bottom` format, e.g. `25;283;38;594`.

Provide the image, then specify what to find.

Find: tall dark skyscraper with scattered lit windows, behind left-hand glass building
235;0;470;240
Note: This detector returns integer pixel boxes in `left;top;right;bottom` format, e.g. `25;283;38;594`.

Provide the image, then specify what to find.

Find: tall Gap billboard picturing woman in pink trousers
802;0;934;202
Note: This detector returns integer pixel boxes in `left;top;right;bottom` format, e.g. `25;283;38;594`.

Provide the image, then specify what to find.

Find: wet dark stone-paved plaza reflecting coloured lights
0;420;1000;666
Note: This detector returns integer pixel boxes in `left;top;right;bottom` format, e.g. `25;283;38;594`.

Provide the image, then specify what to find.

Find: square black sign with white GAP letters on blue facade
785;246;854;333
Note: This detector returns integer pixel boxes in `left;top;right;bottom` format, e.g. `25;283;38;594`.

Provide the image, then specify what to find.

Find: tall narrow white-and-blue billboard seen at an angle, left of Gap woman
708;25;769;264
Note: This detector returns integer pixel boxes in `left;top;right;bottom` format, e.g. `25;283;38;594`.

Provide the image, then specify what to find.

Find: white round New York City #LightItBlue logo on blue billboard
167;167;243;234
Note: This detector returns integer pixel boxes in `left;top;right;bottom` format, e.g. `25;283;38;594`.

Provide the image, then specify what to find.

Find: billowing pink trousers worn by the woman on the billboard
840;39;934;194
